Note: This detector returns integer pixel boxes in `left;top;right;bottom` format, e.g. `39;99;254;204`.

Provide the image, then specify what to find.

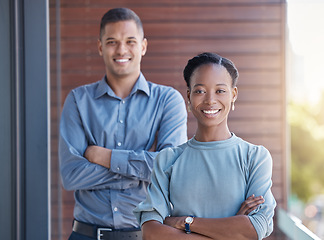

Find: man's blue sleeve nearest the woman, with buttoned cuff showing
110;89;187;181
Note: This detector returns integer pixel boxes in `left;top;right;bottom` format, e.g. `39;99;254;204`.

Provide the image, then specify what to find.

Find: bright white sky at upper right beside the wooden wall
287;0;324;102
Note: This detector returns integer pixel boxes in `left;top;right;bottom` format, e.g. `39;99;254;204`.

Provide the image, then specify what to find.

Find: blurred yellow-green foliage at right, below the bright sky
288;94;324;203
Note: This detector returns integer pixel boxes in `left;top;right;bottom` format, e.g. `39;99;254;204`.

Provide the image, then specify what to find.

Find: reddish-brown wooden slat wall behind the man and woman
50;0;287;239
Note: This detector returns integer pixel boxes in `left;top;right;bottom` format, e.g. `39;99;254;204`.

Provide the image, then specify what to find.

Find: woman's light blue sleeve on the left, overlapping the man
134;148;177;225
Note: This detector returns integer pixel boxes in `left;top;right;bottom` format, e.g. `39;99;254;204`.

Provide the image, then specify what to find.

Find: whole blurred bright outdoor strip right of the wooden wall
287;0;324;239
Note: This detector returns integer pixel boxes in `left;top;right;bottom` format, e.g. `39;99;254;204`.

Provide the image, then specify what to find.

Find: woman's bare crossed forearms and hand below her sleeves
142;195;264;240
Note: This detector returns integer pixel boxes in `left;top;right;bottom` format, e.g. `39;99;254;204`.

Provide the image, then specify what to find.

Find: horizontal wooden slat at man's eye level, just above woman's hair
62;38;282;55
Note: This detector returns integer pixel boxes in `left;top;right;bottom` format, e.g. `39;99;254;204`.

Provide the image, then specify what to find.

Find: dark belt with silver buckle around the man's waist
73;220;142;240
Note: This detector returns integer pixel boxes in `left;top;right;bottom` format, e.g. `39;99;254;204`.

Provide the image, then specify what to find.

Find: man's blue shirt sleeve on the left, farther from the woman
59;91;128;190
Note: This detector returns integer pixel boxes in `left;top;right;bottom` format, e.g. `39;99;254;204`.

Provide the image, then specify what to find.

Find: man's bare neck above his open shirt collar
106;75;139;99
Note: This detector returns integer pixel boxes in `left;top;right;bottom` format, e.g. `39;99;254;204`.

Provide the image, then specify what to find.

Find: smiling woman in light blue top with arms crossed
134;53;276;240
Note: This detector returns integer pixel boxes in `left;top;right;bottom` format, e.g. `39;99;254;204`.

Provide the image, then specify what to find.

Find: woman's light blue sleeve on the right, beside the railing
247;146;276;239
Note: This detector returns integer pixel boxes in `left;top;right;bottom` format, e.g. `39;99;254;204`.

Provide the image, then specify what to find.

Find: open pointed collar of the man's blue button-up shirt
95;73;150;98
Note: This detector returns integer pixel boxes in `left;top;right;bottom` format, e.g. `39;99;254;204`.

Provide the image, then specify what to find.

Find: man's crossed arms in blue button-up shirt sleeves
59;89;187;190
